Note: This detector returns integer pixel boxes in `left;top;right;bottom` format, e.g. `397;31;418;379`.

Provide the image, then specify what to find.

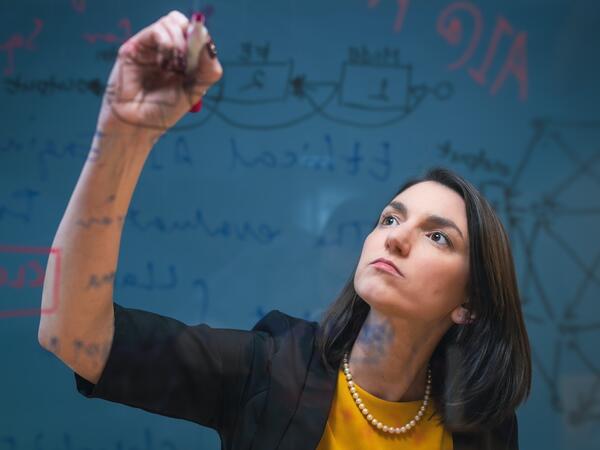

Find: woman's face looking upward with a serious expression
354;181;469;325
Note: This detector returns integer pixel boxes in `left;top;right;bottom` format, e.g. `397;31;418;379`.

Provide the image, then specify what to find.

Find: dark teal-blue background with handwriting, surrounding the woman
0;0;600;450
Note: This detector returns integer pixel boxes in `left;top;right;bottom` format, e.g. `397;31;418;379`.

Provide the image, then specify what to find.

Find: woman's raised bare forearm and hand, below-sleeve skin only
38;11;222;383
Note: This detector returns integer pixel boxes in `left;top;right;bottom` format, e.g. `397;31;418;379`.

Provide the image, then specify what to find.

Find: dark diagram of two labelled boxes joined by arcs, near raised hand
12;37;454;133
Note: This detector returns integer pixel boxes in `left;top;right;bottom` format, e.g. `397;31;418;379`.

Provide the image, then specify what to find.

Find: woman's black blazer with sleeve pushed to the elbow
75;304;518;450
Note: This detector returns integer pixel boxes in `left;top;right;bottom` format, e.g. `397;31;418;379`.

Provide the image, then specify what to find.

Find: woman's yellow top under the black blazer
317;369;453;450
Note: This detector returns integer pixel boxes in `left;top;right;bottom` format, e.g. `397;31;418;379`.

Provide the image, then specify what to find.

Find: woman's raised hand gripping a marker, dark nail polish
98;11;223;135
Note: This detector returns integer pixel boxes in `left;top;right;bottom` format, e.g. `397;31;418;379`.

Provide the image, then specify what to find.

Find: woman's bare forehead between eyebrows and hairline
393;181;468;230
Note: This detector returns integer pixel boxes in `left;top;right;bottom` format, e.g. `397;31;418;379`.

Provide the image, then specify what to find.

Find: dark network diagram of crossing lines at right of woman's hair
479;118;600;427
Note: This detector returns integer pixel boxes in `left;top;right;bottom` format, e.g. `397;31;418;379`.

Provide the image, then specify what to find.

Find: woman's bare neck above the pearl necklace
349;308;445;402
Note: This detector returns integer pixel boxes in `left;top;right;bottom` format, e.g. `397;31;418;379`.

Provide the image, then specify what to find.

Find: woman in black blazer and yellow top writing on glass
38;11;531;450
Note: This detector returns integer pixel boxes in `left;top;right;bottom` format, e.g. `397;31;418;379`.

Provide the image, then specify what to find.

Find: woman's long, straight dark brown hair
316;167;531;431
